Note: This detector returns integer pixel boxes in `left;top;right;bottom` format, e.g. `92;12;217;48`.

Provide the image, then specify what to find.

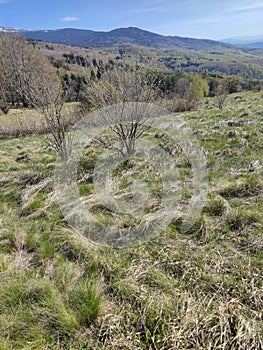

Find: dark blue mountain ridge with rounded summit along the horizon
0;27;238;52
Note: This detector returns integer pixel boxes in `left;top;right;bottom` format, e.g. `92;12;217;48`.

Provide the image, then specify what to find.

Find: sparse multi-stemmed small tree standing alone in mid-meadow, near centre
81;68;163;155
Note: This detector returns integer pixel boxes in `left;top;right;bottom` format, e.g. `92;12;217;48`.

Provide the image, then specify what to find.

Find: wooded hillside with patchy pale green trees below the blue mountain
34;42;263;79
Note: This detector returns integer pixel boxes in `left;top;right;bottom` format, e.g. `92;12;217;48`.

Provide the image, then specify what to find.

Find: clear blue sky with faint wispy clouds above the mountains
0;0;263;39
